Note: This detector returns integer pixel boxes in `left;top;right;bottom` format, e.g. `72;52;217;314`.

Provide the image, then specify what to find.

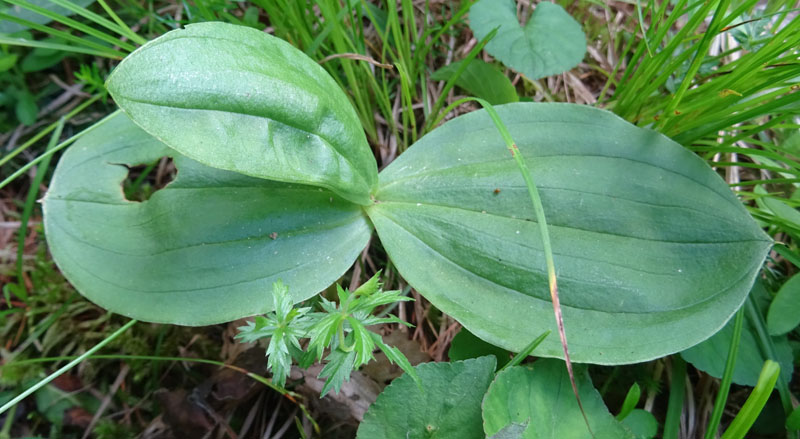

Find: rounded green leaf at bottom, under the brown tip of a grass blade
483;359;633;439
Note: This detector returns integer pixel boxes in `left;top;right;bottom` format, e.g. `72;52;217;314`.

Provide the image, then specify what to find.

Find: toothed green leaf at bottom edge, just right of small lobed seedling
357;356;495;439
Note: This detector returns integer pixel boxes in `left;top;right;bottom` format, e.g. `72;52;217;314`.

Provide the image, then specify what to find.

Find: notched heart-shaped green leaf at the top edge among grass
469;0;586;79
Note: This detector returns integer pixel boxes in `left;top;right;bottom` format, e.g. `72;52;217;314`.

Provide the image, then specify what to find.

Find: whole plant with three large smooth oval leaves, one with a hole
44;23;771;364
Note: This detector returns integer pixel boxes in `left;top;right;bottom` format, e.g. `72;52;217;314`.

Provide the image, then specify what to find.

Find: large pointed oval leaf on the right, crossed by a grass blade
367;103;772;364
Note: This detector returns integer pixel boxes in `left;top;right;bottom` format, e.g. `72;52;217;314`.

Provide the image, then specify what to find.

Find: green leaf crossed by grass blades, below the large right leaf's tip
681;281;793;386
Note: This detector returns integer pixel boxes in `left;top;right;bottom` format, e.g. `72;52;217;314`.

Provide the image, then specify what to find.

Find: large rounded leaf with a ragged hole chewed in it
44;113;370;325
